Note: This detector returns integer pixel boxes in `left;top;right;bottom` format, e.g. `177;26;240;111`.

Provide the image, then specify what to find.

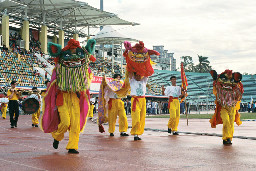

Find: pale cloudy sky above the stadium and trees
82;0;256;74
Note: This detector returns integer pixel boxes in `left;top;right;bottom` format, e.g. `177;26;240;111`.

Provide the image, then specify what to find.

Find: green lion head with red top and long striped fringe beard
48;39;96;92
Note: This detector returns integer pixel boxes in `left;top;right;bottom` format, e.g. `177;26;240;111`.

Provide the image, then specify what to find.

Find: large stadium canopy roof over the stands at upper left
0;0;138;37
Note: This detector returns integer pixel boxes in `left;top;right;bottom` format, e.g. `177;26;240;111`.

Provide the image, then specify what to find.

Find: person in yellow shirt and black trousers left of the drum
7;80;20;128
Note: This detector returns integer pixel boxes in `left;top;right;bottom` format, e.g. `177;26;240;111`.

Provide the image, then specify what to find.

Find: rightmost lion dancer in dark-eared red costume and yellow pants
210;70;244;145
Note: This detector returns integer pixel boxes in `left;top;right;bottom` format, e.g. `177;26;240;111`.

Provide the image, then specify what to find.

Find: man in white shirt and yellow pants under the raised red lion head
129;73;148;141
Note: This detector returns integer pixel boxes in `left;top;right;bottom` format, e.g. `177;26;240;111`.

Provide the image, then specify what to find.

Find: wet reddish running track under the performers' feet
0;115;256;171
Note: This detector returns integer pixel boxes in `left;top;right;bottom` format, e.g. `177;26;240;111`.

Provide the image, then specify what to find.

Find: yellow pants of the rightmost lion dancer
220;107;236;140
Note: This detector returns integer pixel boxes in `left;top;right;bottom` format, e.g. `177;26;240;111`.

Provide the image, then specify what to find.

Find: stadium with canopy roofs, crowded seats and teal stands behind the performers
0;0;256;113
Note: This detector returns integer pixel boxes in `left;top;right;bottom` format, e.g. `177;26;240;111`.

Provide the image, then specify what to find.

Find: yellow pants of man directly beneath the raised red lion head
131;97;146;135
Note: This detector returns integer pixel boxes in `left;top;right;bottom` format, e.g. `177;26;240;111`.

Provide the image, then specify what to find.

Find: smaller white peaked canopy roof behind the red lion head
94;26;138;44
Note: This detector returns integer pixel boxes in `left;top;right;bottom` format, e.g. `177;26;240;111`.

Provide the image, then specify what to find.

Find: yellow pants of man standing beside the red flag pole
168;99;180;131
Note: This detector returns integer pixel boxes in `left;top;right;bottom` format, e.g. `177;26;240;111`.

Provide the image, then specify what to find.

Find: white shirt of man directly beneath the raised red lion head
129;77;148;96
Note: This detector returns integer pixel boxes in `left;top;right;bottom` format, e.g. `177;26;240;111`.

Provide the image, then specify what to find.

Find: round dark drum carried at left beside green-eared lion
22;98;40;114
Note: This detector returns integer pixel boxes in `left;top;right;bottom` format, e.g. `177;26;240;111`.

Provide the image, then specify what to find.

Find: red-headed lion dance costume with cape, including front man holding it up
99;41;160;141
